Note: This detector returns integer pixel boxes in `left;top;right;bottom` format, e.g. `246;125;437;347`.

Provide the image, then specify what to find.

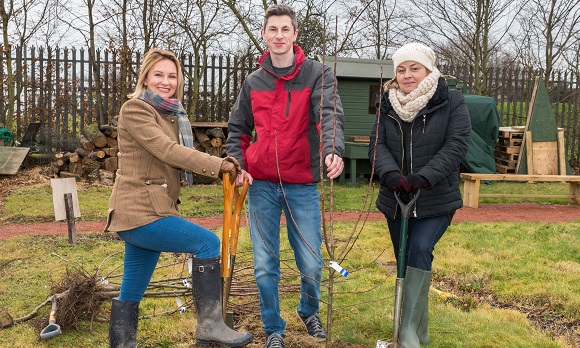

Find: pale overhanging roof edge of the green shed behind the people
317;55;393;80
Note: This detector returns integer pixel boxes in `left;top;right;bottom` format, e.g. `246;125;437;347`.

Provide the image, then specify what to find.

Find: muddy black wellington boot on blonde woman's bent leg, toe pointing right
191;257;254;347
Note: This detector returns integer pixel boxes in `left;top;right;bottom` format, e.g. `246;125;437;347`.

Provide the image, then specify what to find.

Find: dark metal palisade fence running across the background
0;47;580;161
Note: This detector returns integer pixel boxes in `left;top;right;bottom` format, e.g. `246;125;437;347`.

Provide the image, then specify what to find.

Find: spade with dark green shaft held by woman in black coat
377;191;419;348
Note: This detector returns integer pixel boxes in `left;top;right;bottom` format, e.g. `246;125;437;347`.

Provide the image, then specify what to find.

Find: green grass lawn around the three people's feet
0;178;580;348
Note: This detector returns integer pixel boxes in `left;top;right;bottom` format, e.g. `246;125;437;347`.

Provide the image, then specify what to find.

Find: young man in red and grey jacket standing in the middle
227;5;344;347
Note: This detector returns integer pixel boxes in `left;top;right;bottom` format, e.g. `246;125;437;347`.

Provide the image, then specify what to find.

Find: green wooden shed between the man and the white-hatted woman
318;56;394;184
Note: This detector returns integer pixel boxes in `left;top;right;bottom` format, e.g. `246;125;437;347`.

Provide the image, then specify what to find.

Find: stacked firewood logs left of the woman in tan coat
51;118;119;185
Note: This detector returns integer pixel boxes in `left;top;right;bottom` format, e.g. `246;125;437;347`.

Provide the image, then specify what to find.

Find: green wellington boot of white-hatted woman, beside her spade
399;267;432;348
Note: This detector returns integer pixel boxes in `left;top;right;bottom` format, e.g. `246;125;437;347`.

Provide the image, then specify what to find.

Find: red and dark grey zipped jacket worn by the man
226;45;344;184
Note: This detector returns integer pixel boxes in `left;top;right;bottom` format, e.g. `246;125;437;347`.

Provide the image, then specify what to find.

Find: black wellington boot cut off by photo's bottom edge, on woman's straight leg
109;298;139;348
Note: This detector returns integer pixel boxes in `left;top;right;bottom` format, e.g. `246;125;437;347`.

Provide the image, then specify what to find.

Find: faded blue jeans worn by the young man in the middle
248;180;322;335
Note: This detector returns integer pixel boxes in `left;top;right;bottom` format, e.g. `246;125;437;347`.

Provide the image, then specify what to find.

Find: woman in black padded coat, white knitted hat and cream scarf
369;43;471;348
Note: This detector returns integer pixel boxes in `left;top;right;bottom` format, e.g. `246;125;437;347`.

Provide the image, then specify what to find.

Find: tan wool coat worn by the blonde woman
105;99;222;231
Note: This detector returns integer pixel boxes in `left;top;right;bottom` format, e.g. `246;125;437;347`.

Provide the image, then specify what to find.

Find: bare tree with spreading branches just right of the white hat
410;0;521;95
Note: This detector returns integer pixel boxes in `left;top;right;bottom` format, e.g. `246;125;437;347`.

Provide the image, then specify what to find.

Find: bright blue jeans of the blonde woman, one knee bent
117;216;220;302
